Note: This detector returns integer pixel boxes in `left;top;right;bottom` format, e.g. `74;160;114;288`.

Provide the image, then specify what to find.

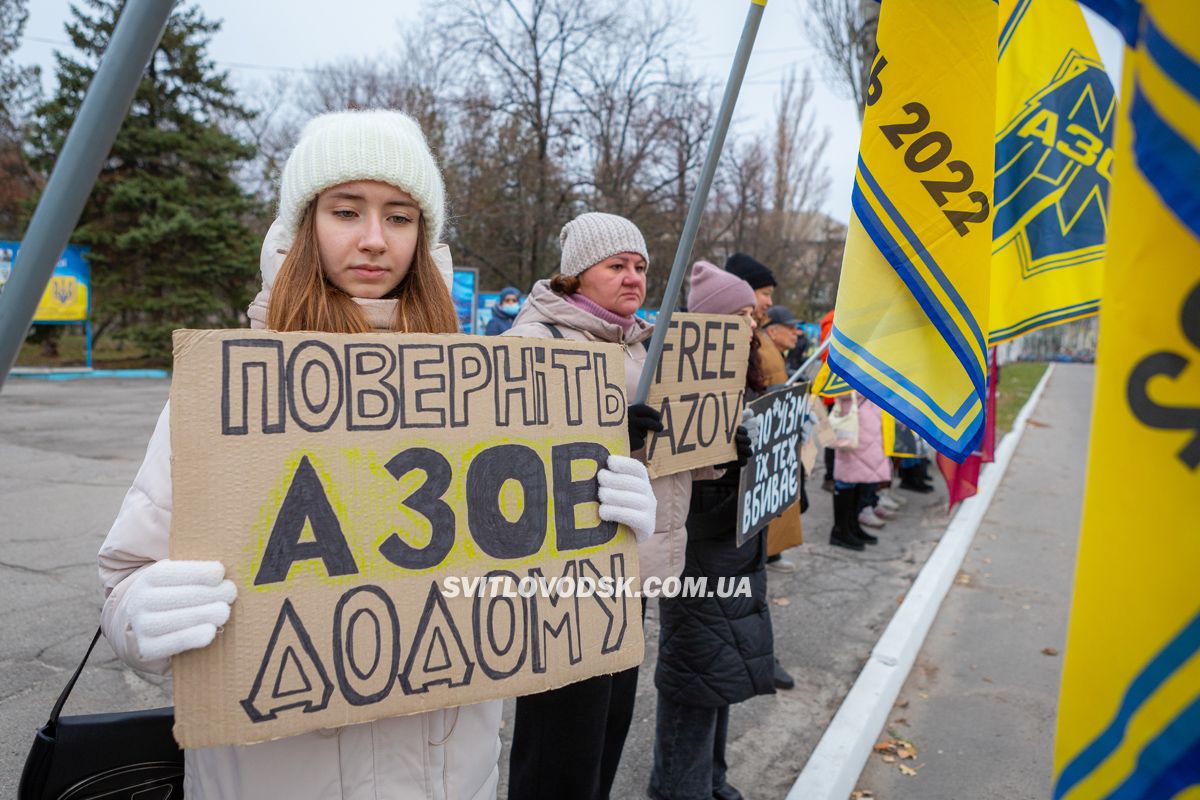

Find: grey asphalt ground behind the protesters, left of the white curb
0;367;1091;799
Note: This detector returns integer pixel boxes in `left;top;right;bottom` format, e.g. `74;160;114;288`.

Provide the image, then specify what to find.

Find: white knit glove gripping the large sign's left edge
126;559;238;661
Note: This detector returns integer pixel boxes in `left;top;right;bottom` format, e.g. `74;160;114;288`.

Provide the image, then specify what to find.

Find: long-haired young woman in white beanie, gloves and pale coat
100;110;654;800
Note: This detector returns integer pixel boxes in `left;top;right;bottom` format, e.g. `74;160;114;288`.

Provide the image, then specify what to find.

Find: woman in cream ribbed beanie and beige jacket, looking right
504;212;749;800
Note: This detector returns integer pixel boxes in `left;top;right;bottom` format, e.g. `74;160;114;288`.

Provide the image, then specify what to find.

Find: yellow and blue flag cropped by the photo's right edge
1054;0;1200;800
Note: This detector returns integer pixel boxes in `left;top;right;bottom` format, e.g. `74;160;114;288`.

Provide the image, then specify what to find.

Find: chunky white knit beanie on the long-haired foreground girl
280;109;445;246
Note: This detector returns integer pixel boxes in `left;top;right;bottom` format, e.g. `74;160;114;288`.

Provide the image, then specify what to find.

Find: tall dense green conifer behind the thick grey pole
30;0;262;361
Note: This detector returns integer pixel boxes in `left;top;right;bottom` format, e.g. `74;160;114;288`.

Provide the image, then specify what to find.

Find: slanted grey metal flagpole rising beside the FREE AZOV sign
634;0;767;403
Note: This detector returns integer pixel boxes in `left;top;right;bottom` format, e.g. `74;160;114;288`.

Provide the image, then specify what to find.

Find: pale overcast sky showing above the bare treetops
14;0;1121;222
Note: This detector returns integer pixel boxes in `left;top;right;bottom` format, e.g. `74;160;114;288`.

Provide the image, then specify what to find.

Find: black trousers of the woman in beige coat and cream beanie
509;600;646;800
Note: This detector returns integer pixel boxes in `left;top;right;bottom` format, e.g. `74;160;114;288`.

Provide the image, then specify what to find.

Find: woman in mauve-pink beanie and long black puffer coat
648;261;775;800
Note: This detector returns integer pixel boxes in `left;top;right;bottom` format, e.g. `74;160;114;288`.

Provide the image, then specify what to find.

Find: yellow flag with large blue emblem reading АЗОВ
988;0;1116;344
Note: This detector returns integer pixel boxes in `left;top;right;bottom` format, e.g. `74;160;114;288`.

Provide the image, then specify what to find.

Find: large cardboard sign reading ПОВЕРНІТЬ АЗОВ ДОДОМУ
170;330;643;747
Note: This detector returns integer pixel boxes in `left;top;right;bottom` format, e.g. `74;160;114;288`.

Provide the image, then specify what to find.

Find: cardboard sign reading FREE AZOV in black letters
646;314;751;477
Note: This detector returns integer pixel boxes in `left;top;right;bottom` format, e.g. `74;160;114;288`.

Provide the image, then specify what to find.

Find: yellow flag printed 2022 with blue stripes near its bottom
829;0;998;461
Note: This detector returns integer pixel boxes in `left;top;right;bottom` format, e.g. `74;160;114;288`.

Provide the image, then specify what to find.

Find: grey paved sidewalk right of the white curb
858;365;1094;800
